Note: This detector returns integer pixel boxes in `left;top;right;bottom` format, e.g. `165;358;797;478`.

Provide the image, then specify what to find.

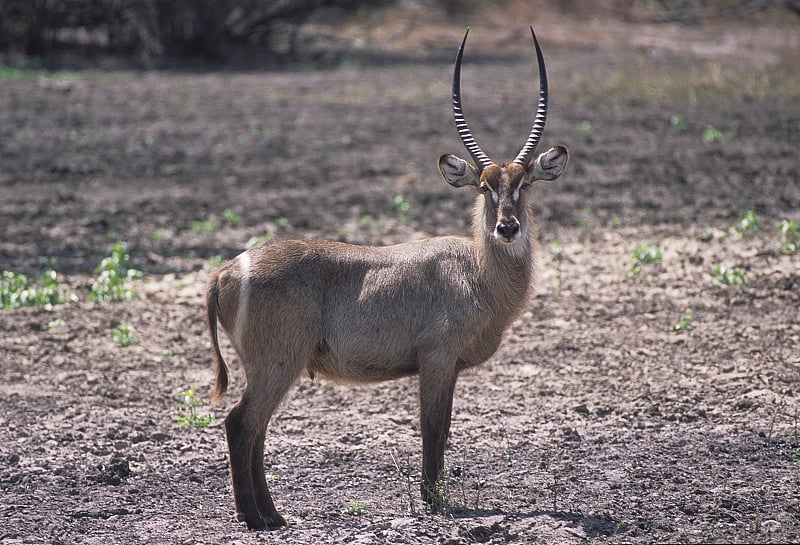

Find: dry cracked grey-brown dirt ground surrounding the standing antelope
0;4;800;545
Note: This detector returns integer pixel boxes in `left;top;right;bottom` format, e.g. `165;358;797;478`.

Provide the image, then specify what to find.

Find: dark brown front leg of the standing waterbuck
419;368;456;511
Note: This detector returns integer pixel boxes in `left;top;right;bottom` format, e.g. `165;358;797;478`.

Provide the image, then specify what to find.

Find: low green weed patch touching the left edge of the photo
0;270;78;310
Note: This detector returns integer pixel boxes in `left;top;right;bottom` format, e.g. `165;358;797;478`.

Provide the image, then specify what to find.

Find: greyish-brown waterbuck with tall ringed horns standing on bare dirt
206;27;569;529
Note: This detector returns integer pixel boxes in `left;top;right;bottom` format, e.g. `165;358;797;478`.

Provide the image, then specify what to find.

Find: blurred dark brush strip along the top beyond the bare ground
0;0;800;67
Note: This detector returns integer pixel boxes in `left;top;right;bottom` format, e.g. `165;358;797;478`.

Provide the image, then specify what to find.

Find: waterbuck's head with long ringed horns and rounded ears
439;26;569;246
